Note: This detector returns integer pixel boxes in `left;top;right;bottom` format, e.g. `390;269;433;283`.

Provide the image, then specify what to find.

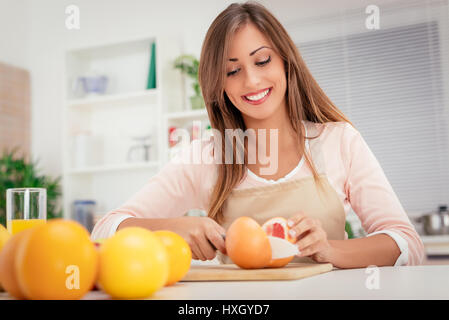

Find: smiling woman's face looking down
224;23;286;120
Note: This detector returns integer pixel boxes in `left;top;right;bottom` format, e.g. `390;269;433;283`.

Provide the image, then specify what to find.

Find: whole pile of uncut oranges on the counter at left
0;219;192;300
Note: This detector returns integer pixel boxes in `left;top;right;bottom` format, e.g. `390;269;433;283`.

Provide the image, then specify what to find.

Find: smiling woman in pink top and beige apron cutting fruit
92;2;423;268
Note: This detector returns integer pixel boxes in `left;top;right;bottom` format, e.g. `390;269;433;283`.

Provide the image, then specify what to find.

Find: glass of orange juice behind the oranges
6;188;47;234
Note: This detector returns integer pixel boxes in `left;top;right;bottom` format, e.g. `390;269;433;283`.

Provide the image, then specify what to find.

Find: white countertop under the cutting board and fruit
0;265;449;300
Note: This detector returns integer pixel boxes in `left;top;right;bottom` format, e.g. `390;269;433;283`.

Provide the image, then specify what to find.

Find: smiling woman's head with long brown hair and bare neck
199;2;350;219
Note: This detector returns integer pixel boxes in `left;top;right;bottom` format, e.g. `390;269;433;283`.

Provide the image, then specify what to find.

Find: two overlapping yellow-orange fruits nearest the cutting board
98;227;192;299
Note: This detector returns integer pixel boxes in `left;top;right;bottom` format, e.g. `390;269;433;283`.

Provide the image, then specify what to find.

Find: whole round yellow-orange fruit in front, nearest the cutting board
98;227;169;299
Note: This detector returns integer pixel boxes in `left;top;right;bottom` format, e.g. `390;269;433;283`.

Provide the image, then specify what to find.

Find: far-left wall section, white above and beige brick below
0;0;31;159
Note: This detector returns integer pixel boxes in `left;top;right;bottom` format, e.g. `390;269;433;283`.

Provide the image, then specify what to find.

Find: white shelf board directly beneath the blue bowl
68;89;158;108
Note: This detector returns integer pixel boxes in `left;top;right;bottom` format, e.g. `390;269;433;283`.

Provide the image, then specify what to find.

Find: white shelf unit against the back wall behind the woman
62;37;185;218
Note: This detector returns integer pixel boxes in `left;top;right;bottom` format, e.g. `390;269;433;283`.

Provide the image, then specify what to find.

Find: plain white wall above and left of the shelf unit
25;0;238;175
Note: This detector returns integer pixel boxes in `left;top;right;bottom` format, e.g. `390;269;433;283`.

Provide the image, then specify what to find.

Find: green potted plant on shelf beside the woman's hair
174;54;205;109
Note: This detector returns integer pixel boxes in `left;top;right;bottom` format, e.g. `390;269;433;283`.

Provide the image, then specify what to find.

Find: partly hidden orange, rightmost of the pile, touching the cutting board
154;230;192;286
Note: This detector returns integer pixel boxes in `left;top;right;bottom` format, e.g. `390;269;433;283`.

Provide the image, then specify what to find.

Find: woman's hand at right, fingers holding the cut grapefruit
288;211;332;262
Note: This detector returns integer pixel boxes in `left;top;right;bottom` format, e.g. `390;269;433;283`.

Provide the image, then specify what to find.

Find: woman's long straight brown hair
199;1;352;222
